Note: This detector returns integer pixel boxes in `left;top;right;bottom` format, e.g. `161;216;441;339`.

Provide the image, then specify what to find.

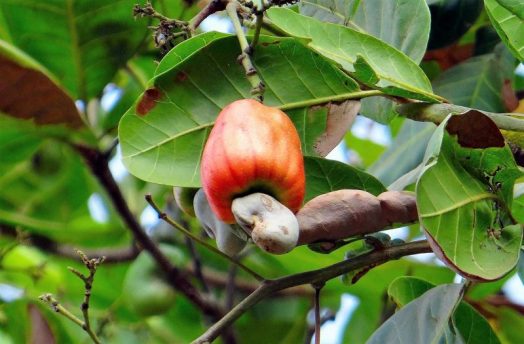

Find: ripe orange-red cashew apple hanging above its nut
200;99;305;224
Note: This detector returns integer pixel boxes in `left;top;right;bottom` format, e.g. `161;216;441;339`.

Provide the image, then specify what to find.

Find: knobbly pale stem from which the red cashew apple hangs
226;1;265;102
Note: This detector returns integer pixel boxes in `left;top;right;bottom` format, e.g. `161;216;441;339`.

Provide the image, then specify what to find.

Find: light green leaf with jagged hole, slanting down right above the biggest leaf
267;7;439;101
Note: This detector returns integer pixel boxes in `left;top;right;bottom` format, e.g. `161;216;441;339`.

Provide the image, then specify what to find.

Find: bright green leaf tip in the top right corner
484;0;524;61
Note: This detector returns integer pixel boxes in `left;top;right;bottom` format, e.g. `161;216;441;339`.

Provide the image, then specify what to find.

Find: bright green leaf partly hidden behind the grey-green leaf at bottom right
388;276;500;344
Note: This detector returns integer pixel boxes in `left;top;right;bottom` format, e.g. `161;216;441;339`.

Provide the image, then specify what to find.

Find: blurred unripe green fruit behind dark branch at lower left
122;244;185;317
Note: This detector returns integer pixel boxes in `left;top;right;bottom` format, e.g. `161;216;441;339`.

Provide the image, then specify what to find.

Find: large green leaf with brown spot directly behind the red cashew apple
119;33;358;186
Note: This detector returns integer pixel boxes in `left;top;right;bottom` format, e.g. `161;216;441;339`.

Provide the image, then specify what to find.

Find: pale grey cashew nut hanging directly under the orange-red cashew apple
231;193;299;254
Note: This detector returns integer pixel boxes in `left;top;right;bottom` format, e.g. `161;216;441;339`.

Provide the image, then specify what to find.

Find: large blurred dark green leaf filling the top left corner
0;0;147;100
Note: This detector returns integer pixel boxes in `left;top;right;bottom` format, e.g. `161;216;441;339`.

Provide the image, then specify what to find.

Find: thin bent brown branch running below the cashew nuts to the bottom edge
193;240;431;344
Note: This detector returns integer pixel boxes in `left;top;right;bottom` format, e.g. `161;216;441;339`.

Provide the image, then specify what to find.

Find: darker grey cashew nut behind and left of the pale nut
193;189;248;256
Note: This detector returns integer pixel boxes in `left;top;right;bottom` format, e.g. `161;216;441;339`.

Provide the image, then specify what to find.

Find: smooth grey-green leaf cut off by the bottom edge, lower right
367;284;463;344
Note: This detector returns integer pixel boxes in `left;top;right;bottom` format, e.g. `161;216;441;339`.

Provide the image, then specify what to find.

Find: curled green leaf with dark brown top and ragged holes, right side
417;113;522;280
